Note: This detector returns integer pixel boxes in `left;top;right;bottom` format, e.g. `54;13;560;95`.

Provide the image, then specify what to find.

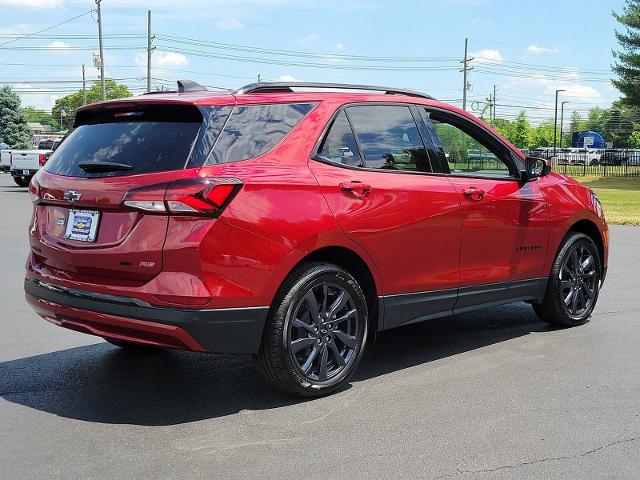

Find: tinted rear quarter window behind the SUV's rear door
207;103;315;164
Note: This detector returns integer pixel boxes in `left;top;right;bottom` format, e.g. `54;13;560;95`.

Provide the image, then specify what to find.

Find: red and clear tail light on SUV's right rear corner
122;178;242;217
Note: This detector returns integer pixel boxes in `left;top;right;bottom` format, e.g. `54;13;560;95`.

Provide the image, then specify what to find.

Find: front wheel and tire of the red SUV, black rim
533;232;602;328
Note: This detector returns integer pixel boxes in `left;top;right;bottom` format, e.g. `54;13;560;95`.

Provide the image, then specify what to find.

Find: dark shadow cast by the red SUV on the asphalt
0;303;552;426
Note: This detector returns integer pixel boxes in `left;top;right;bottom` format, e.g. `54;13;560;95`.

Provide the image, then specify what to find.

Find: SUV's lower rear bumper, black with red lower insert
24;279;269;353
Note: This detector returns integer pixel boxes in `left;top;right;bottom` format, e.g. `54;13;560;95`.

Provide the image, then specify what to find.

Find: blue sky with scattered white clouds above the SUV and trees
0;0;623;122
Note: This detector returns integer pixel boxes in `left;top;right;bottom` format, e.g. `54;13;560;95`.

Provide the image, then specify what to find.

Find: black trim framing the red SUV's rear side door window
309;101;444;176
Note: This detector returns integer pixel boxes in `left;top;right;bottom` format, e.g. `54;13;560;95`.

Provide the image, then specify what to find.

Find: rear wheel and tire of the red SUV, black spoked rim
257;262;368;397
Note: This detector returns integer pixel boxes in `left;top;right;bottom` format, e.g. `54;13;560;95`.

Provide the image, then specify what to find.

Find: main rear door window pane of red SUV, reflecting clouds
345;105;431;172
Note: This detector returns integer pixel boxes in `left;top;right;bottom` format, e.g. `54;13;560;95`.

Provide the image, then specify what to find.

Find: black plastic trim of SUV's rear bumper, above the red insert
24;279;269;353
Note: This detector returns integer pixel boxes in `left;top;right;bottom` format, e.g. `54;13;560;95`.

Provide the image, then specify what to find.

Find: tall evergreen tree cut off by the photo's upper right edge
611;0;640;106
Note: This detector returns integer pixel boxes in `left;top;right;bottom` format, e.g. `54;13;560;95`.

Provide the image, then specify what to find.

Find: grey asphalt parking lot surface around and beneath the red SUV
0;174;640;479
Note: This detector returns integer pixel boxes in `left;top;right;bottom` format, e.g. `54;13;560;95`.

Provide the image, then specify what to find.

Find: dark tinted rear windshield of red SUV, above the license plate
45;106;202;177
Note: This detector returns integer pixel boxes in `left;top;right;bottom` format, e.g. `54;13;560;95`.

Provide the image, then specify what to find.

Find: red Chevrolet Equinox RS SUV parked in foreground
25;81;608;396
